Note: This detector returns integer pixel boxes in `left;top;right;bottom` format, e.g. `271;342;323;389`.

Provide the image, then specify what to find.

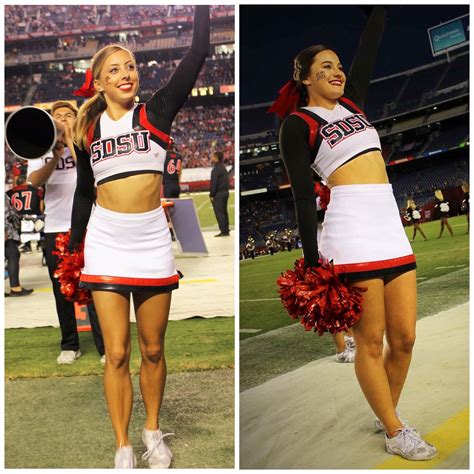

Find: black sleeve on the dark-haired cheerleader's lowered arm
280;115;319;266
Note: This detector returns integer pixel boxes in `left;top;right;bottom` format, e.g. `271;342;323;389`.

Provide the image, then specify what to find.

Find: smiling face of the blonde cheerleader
94;49;138;104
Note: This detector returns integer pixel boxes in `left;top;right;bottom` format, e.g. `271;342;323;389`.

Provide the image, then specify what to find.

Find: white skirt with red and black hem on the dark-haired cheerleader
319;184;416;279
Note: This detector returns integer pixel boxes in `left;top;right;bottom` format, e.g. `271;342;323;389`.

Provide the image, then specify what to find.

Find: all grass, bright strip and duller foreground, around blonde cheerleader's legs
4;318;235;468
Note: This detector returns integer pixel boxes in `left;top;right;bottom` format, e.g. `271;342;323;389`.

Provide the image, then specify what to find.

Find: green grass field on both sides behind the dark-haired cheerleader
239;216;469;390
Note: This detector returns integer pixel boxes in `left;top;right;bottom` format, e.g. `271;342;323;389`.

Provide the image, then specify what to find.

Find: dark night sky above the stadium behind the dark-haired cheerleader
240;5;469;105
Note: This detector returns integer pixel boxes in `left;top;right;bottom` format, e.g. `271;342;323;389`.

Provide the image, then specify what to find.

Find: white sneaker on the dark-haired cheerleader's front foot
385;428;438;461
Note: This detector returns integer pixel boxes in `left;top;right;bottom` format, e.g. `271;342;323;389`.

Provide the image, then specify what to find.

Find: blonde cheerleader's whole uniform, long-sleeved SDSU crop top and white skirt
70;5;210;292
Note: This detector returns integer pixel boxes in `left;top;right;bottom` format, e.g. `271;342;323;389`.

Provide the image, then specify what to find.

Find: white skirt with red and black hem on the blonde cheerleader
81;206;179;293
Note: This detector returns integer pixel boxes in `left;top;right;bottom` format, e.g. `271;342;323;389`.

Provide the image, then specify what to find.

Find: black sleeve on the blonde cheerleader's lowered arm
69;147;95;251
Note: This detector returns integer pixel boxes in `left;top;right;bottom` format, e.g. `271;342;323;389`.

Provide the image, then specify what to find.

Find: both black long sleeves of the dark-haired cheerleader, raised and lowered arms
280;7;386;266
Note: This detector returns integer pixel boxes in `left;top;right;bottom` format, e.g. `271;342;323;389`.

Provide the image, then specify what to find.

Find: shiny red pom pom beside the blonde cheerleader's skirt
53;230;92;305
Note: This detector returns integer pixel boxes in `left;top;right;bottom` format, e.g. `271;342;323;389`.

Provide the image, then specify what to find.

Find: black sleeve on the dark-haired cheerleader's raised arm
344;6;386;108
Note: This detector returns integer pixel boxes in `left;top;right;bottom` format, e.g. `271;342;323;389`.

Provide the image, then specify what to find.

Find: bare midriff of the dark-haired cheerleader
327;151;389;188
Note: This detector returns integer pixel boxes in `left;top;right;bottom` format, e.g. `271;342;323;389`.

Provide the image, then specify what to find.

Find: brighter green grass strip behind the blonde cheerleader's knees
5;318;234;380
